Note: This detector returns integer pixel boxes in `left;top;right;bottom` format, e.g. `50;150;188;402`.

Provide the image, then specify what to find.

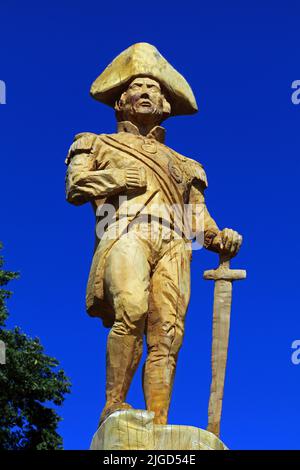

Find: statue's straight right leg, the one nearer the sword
143;240;190;424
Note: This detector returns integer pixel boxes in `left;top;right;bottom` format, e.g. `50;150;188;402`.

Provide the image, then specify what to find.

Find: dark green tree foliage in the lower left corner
0;244;70;450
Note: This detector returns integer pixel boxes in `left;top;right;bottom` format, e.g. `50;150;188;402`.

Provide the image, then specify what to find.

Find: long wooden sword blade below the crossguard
207;279;232;436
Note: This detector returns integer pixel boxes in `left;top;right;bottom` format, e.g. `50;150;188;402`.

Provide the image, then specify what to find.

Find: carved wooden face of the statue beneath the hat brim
115;77;171;126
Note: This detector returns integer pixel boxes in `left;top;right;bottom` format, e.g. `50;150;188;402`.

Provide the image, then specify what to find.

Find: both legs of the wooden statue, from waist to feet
104;223;190;424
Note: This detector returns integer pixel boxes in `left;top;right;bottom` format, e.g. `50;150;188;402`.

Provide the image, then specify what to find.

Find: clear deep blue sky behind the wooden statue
0;0;300;449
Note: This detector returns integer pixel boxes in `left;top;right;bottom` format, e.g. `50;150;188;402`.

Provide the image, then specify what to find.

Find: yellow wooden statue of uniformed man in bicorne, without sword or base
66;43;242;424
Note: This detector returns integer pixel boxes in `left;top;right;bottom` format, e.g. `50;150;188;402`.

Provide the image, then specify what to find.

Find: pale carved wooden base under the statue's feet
90;409;227;450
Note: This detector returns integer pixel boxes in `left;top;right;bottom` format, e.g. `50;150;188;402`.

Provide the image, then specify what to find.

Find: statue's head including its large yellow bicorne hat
91;42;198;118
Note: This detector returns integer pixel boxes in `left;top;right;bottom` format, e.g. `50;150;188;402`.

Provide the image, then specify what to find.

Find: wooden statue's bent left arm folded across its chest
66;134;146;205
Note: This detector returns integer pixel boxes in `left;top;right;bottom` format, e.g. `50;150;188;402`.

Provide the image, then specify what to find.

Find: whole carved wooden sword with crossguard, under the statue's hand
203;255;246;436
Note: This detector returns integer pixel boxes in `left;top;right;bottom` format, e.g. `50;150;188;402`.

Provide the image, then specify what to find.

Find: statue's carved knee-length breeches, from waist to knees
104;220;190;355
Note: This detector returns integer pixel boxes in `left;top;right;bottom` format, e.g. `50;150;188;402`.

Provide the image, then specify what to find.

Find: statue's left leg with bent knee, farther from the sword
101;233;150;419
